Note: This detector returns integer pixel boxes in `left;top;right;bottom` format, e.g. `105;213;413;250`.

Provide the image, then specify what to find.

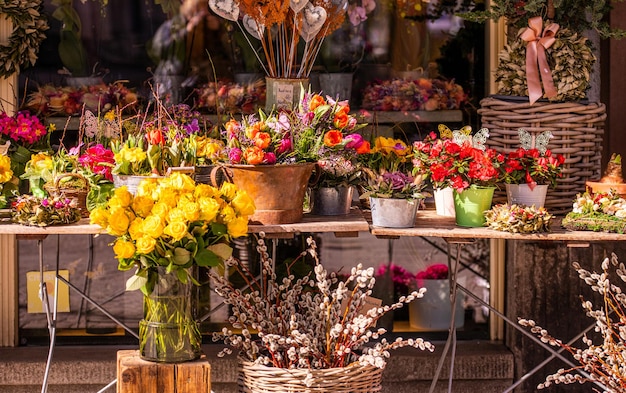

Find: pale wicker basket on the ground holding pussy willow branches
237;359;383;393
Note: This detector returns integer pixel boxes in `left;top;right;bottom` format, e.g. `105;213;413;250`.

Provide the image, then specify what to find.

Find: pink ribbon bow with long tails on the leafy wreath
521;16;559;105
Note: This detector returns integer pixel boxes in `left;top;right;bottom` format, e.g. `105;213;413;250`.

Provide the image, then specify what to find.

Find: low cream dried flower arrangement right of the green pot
485;204;553;233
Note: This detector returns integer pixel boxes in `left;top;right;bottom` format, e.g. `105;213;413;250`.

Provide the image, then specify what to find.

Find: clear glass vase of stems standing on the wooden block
139;268;202;363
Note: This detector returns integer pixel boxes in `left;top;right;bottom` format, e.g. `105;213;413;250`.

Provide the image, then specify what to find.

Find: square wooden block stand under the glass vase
117;350;211;393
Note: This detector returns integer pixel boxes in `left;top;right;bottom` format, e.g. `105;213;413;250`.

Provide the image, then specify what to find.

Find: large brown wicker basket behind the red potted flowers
478;97;606;214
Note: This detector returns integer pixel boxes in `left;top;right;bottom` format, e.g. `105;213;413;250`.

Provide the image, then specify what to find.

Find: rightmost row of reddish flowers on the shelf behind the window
361;78;467;111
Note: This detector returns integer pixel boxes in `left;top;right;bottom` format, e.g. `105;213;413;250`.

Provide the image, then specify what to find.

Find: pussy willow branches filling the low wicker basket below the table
209;234;434;370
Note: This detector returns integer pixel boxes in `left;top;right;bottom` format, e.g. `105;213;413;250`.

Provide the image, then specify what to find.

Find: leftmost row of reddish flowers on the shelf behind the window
25;82;139;117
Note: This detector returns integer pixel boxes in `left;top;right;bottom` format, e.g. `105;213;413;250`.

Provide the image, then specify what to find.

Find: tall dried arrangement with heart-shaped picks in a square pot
209;0;376;111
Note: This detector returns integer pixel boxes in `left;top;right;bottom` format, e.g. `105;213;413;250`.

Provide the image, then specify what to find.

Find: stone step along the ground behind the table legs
0;340;513;393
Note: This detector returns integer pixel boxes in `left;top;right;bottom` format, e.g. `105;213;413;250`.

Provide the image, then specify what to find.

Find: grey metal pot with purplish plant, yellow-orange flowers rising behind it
360;136;427;228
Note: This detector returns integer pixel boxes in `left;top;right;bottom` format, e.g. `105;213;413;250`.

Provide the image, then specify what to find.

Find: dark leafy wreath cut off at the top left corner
0;0;48;78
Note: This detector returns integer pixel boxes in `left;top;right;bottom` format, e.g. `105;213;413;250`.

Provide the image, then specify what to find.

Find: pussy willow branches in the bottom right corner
519;254;626;393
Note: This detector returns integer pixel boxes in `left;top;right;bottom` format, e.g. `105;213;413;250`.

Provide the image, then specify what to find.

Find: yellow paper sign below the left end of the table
26;270;70;314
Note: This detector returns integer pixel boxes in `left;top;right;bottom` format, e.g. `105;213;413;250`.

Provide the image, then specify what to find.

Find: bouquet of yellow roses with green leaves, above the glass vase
90;172;255;296
